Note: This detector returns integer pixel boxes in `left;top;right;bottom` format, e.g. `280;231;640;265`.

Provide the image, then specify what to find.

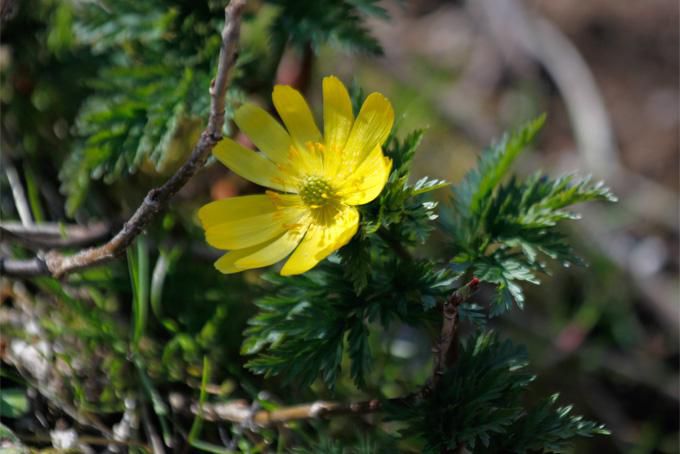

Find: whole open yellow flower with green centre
198;76;394;276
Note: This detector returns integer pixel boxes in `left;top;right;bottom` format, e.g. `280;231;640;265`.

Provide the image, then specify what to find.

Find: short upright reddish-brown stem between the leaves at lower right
426;277;479;390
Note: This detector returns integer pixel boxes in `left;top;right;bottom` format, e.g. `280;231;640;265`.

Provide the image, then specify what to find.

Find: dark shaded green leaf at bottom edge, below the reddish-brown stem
386;332;533;453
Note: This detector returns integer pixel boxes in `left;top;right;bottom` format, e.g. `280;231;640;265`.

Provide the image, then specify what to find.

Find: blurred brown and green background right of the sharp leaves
342;0;680;453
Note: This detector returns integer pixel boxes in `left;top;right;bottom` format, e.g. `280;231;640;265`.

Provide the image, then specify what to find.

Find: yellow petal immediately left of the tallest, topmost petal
272;85;321;150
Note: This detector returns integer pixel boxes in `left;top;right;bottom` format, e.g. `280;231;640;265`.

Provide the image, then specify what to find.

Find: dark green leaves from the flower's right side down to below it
243;127;454;388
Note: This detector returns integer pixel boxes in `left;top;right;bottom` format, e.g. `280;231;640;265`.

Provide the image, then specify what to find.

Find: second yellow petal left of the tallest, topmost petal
234;104;292;163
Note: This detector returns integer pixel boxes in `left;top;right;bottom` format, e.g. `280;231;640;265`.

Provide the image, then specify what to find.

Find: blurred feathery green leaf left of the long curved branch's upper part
61;1;221;213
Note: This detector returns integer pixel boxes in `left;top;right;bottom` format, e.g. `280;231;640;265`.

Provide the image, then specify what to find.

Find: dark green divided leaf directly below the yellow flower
242;260;451;388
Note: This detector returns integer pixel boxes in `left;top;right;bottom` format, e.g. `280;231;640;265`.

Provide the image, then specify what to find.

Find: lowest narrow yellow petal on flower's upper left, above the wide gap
213;138;297;192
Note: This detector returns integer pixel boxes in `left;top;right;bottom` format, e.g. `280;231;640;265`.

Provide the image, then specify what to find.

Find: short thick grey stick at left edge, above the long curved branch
0;222;111;249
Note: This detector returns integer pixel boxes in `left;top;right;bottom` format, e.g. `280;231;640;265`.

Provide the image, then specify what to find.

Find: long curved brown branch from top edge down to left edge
0;0;245;277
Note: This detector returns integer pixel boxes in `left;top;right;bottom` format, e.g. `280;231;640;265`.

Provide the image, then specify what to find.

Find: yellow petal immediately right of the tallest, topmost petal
343;93;394;175
